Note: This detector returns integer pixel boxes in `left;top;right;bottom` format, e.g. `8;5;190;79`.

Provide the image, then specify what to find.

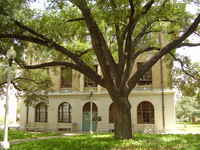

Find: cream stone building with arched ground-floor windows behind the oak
20;54;175;132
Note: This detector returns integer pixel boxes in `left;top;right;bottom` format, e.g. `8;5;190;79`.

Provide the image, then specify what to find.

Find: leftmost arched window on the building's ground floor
35;103;47;122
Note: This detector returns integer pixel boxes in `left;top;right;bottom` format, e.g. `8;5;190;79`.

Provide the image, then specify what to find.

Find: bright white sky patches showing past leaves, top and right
31;0;200;62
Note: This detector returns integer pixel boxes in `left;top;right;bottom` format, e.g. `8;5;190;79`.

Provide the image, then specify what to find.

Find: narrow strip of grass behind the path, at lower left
0;130;60;141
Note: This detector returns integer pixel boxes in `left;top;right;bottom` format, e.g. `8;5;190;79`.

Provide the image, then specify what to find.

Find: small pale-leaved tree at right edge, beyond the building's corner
173;60;200;122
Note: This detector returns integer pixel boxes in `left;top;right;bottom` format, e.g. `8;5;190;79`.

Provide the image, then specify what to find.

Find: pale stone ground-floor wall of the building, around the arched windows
21;90;175;132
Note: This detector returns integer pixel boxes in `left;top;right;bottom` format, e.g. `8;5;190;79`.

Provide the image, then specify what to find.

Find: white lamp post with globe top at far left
0;47;16;150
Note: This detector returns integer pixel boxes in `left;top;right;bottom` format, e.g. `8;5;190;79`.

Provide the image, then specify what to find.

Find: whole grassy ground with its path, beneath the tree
0;124;200;150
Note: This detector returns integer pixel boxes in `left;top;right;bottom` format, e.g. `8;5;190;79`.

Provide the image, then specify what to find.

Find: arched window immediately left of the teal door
58;102;71;123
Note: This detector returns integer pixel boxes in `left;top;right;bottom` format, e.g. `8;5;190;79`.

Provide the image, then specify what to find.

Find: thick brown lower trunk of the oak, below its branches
114;96;132;139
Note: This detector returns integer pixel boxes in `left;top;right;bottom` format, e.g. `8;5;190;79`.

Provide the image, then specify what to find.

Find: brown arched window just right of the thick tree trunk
137;101;154;124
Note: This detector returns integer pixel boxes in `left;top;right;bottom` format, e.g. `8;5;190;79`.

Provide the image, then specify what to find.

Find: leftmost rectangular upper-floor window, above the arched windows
61;67;72;88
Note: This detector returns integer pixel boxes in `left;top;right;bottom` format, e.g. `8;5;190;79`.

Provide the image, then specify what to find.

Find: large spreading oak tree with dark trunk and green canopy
0;0;200;139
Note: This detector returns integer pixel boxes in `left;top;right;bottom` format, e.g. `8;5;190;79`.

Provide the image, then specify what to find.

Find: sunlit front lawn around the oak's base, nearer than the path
11;134;200;150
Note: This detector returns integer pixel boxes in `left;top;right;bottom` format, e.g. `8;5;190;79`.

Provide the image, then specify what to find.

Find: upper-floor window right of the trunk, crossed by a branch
137;62;152;85
